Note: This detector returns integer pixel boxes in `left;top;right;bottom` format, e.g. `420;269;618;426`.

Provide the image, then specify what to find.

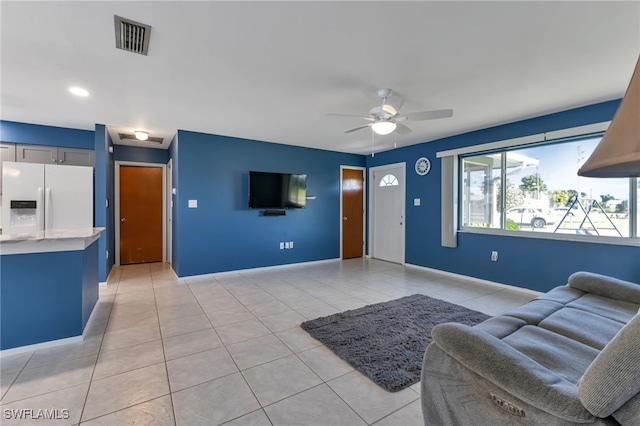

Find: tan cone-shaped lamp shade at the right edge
578;58;640;178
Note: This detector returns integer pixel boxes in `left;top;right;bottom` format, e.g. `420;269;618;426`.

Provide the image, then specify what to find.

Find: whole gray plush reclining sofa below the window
421;272;640;425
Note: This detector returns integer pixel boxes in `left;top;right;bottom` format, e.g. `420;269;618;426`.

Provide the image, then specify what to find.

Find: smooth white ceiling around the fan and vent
0;1;640;153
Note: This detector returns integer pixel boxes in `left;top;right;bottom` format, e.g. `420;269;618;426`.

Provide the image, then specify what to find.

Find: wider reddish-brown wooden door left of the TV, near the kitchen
120;166;162;265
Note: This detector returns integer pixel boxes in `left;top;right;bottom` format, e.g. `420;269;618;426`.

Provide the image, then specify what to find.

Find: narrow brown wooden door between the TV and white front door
342;169;364;259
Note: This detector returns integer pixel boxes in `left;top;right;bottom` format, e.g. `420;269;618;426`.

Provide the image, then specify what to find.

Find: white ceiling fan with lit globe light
327;89;453;135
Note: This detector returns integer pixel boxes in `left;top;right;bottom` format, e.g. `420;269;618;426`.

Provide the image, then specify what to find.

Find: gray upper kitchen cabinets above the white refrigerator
16;145;95;167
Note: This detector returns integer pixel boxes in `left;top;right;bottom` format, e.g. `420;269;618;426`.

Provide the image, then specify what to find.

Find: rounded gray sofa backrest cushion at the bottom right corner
578;314;640;421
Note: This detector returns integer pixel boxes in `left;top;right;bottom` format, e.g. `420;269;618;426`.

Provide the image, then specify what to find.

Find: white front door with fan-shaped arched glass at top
370;163;405;263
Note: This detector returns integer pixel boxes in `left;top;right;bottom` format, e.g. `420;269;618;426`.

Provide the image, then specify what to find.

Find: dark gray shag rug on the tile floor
301;294;489;392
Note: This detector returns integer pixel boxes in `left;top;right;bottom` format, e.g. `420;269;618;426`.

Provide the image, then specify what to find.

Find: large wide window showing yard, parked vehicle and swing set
461;137;640;237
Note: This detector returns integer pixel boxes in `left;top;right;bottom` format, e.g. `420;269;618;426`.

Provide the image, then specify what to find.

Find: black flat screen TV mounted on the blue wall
249;172;307;209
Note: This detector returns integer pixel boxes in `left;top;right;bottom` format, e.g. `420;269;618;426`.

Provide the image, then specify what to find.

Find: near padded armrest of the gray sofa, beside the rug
431;323;594;423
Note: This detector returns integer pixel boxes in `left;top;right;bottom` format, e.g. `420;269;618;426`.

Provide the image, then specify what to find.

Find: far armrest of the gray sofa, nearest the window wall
569;272;640;304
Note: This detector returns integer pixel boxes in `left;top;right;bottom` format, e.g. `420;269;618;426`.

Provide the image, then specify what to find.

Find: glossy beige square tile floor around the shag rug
0;259;533;426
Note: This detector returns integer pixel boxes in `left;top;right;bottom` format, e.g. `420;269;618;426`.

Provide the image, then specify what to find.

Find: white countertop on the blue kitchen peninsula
0;228;105;255
